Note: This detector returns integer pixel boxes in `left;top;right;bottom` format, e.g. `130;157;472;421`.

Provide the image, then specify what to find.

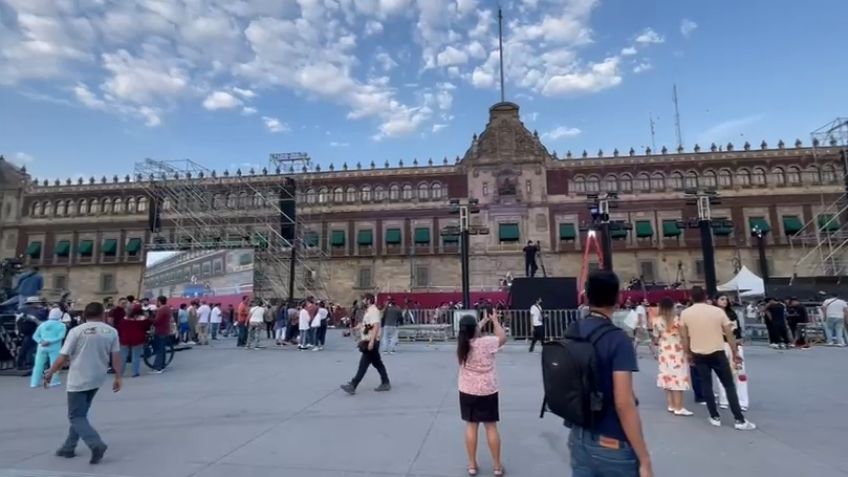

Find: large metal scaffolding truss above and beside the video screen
134;154;327;298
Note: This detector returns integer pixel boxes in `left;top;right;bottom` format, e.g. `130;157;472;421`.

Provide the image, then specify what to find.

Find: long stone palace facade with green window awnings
0;103;844;302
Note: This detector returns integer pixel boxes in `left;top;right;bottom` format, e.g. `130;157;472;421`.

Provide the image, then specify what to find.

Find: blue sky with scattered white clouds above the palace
0;0;848;179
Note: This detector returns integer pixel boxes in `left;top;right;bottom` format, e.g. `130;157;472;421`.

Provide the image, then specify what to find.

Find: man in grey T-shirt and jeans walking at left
44;303;122;464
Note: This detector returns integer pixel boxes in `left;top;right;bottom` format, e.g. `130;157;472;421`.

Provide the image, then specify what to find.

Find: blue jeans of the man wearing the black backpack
568;427;639;477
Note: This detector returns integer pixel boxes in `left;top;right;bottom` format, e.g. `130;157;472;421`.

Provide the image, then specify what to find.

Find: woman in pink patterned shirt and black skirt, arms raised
456;309;506;476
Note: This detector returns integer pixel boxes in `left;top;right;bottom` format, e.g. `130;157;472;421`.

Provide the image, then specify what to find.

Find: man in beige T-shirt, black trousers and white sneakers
681;287;757;431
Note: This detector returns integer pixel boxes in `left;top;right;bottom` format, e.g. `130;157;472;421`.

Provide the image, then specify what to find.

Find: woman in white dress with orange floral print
654;298;692;416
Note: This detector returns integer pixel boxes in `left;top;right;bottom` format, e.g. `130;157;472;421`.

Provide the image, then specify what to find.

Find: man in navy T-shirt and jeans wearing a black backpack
542;270;653;477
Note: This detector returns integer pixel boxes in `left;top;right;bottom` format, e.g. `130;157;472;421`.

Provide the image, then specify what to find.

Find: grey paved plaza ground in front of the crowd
0;332;848;477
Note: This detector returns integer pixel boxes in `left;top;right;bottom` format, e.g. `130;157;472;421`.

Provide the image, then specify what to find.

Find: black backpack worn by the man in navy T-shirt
539;320;618;429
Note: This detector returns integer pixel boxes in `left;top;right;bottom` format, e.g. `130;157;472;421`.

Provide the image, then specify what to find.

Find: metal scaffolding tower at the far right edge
789;118;848;276
